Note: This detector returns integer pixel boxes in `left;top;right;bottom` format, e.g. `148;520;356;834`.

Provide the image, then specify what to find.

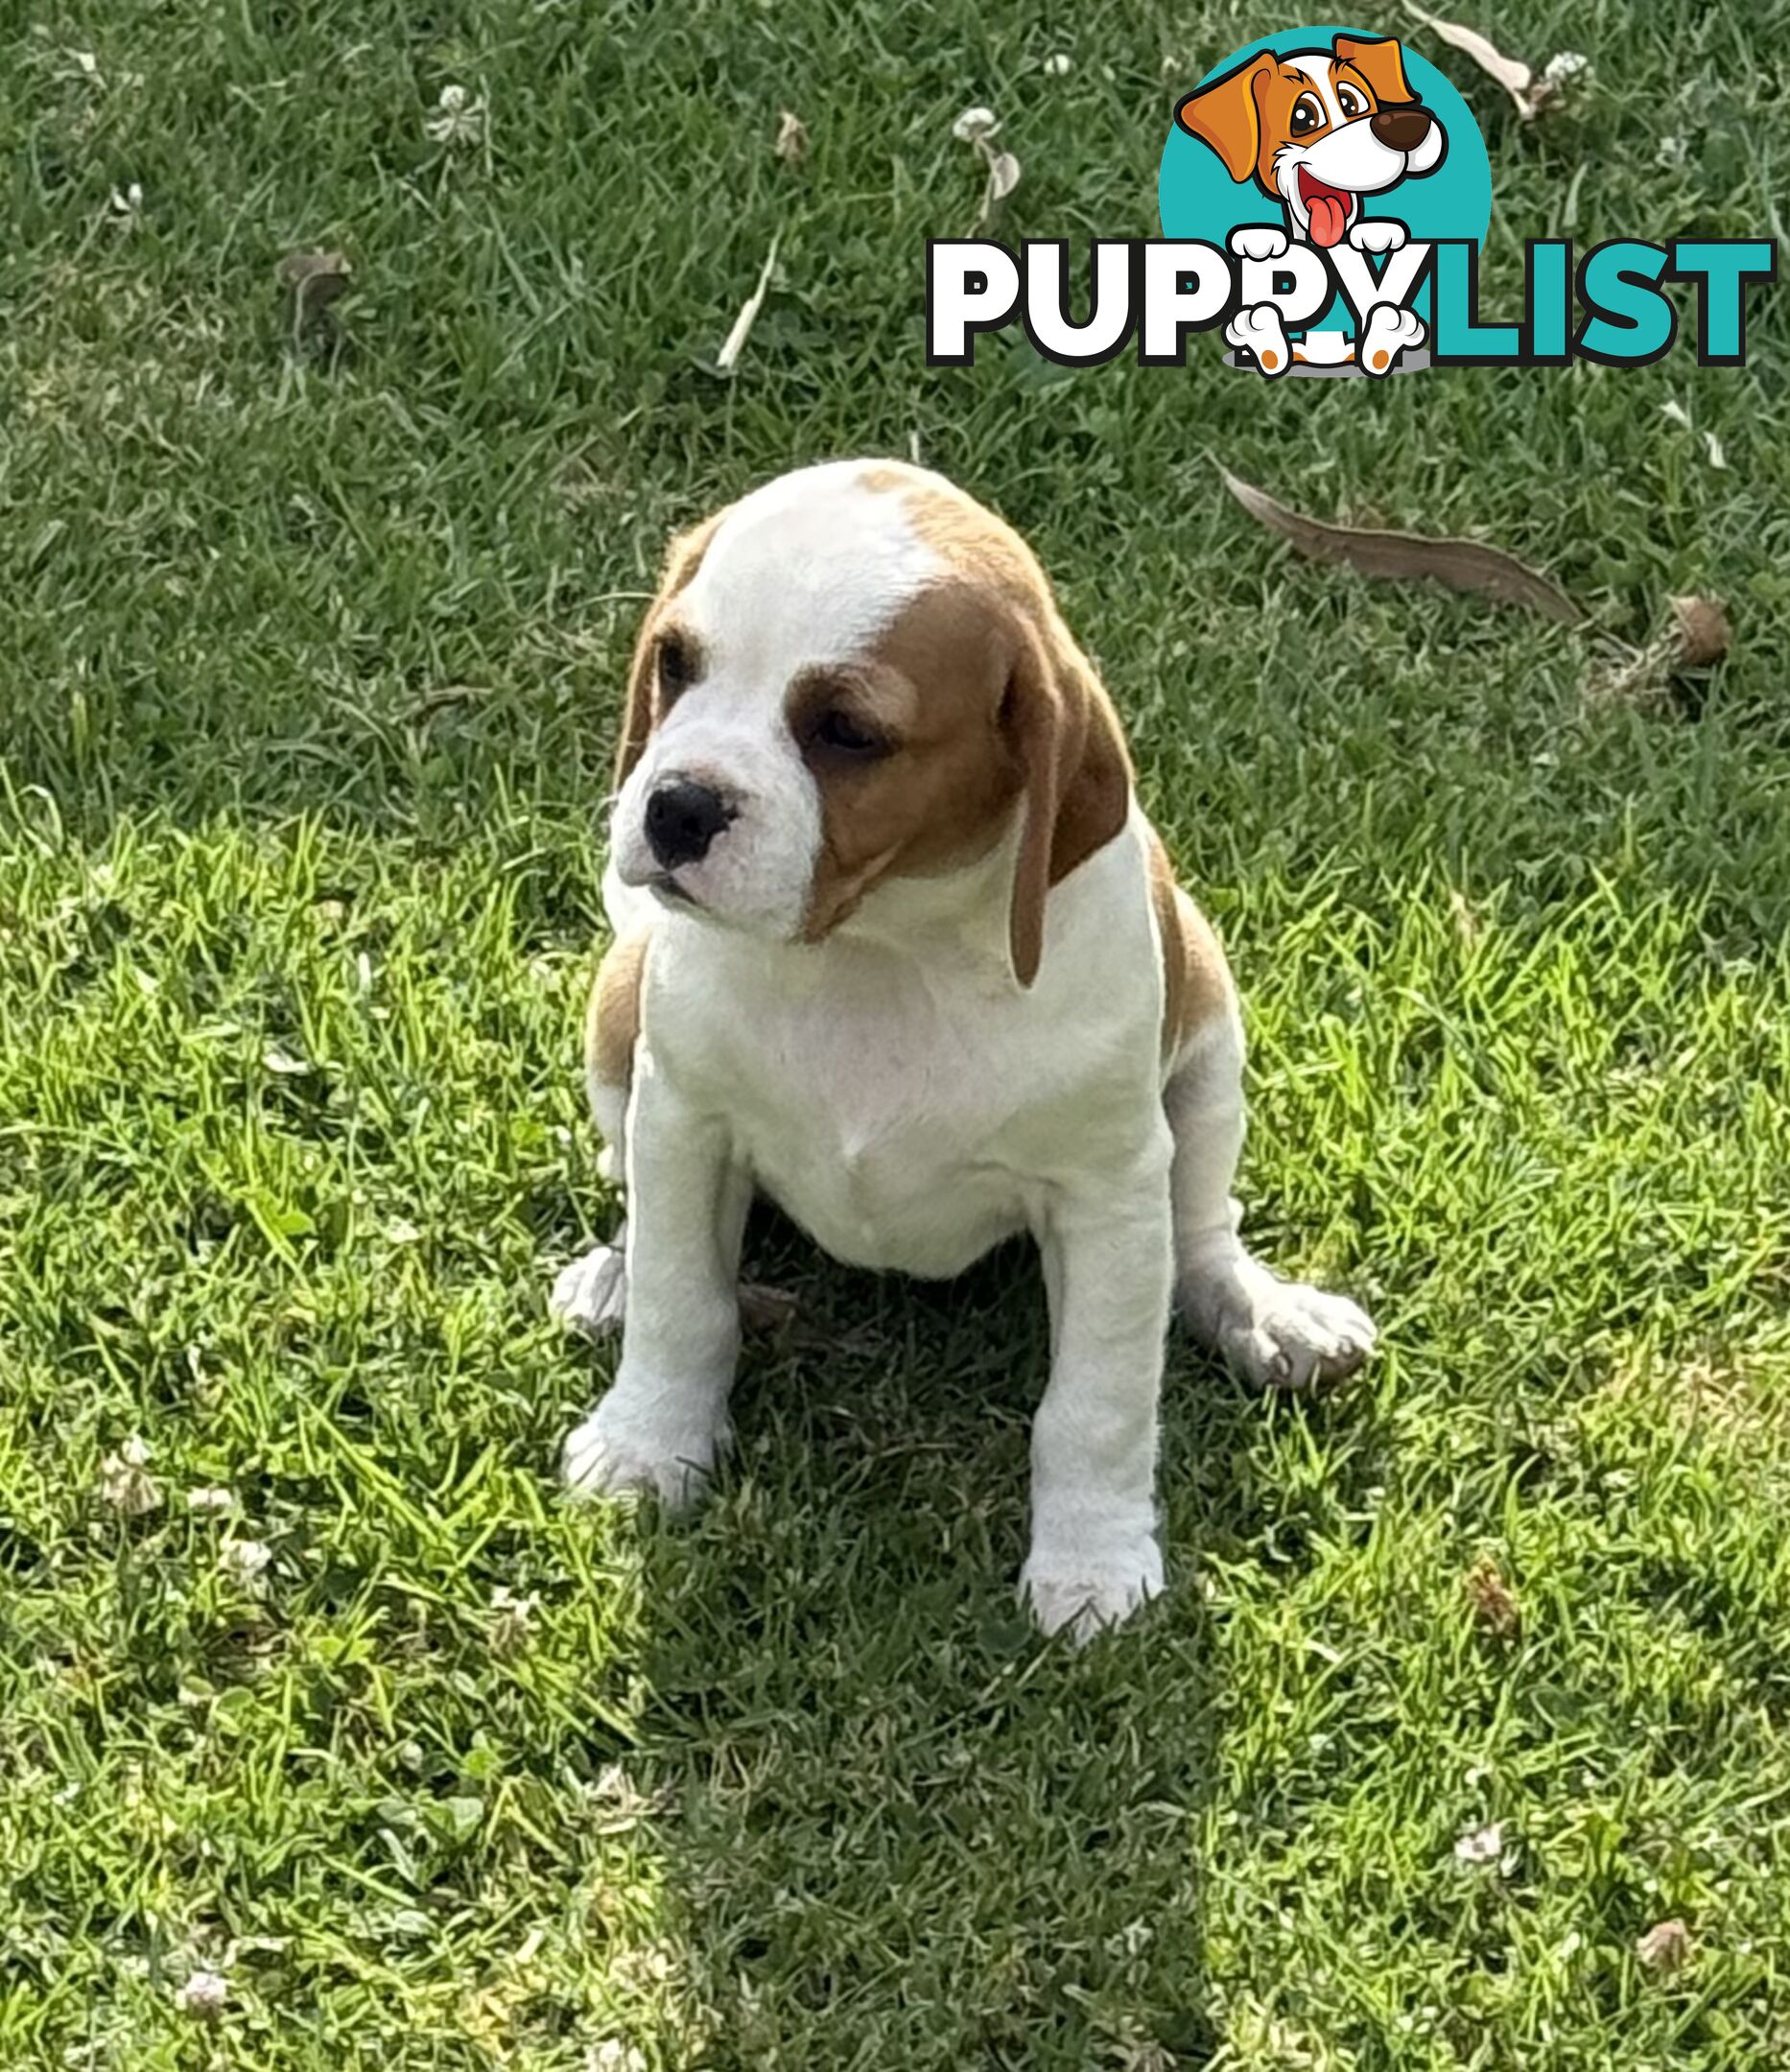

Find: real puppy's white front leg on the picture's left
566;1050;752;1504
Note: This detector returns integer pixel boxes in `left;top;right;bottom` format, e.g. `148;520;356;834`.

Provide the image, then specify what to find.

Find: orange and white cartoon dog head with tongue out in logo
1175;35;1448;245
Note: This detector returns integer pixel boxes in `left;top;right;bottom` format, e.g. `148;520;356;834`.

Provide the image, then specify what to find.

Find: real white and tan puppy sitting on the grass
555;462;1374;1633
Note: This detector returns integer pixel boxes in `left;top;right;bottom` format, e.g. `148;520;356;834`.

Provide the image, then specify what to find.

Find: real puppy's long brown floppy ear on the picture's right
1001;620;1131;986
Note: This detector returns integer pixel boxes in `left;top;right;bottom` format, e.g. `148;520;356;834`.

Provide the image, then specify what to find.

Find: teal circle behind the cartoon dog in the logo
1156;23;1492;332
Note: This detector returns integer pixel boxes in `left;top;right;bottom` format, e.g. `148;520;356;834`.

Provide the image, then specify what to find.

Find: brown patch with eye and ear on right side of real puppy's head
812;462;1131;984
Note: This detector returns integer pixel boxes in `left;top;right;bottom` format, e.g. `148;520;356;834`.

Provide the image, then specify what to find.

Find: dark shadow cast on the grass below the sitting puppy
588;1225;1400;2072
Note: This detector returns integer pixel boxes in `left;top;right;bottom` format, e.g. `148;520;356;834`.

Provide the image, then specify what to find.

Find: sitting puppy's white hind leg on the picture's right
1163;1001;1374;1388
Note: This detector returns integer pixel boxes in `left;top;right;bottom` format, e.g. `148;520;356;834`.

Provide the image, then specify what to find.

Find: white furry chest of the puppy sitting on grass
630;823;1163;1277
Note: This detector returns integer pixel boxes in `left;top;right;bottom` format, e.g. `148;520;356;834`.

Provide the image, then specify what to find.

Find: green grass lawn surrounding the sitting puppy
0;0;1790;2072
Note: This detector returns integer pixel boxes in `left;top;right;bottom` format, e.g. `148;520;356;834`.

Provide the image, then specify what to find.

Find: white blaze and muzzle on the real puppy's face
613;462;943;941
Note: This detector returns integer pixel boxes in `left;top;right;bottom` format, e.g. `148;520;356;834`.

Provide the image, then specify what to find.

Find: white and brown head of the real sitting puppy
613;462;1131;984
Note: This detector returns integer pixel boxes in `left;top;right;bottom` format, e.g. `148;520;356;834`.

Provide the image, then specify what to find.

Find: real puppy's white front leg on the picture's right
1020;1143;1172;1639
